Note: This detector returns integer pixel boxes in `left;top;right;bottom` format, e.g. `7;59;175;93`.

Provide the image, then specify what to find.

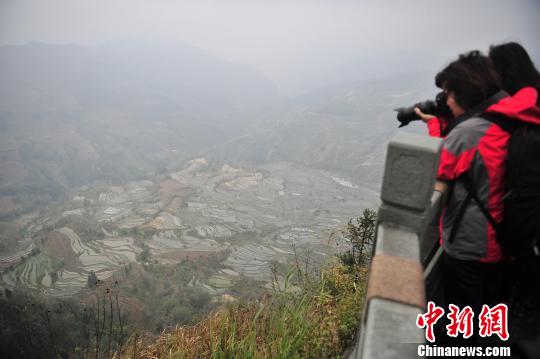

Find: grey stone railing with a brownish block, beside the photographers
349;133;441;359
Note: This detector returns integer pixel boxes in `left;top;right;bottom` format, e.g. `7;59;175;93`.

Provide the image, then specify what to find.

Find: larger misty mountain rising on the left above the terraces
0;41;280;217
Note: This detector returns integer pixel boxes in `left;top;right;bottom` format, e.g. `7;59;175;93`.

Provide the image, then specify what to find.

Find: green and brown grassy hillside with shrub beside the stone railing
121;210;375;358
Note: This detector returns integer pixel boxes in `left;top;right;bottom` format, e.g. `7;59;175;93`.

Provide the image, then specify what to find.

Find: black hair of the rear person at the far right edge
489;42;540;95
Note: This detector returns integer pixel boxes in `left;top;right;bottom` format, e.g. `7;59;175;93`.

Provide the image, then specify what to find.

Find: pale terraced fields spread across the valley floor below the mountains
0;159;378;295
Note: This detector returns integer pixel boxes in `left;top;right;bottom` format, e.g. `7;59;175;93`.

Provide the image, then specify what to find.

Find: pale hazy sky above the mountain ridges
0;0;540;93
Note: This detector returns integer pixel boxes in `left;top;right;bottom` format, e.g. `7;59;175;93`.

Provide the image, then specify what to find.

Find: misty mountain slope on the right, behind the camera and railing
207;73;436;190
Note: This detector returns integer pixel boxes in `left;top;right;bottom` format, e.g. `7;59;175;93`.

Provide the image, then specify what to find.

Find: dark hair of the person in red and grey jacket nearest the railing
435;50;502;110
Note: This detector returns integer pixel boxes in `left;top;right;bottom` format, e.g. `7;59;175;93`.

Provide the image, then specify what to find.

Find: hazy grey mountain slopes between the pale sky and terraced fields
0;41;435;218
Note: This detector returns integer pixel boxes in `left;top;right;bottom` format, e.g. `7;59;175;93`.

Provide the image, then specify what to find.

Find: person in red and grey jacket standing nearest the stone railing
428;51;510;334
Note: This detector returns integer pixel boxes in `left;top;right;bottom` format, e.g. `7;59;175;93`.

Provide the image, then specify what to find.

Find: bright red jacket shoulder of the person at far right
486;87;540;125
